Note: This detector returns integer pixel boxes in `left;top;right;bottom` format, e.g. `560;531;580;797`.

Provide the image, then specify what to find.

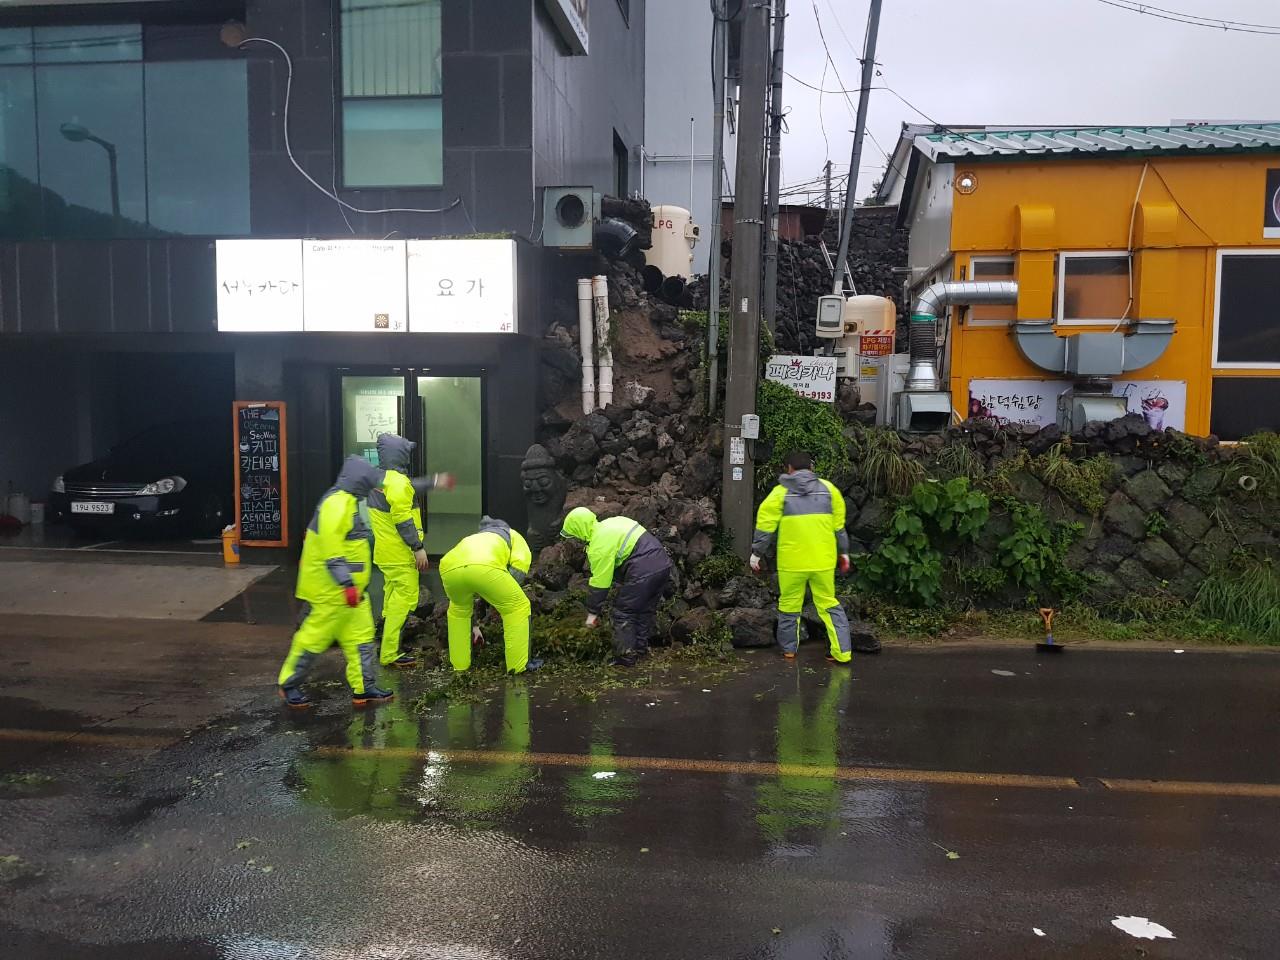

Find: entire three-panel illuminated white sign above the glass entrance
216;239;517;333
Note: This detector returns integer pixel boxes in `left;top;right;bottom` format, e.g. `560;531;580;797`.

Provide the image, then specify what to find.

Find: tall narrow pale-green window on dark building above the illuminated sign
342;0;444;187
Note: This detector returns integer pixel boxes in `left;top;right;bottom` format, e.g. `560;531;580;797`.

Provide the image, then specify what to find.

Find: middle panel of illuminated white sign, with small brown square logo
302;239;408;333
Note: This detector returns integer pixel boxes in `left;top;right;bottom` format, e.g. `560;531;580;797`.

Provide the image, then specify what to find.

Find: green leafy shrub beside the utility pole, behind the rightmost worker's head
755;380;849;490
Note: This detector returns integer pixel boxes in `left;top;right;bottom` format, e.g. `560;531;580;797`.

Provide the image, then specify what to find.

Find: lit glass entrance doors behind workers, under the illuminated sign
340;370;484;556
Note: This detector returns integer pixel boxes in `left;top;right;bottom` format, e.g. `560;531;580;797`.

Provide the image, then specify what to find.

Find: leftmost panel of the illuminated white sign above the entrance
218;241;302;333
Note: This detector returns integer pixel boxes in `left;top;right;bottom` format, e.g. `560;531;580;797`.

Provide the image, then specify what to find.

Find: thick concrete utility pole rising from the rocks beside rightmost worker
721;0;769;558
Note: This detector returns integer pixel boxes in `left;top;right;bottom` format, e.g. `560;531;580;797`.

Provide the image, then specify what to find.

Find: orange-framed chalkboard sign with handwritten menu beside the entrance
232;401;289;547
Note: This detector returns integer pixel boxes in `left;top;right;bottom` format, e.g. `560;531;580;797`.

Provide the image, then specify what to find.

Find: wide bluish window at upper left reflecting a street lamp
0;23;250;239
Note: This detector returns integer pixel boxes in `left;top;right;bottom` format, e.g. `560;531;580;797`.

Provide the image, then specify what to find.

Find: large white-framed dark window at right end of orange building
1213;251;1280;369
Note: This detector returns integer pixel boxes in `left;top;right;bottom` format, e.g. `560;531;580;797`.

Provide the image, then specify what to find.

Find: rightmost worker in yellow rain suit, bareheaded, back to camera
751;452;852;663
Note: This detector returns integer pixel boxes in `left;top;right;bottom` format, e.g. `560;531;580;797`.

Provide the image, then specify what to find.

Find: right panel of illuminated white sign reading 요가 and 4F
408;239;516;333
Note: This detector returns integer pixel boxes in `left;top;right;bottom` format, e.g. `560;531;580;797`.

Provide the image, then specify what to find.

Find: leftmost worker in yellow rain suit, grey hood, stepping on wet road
276;457;393;709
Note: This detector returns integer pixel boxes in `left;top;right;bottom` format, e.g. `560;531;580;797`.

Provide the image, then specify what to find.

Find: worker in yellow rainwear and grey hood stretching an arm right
369;434;453;667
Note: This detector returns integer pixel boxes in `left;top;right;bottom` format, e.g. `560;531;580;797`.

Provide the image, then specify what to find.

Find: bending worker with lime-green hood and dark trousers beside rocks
561;507;671;667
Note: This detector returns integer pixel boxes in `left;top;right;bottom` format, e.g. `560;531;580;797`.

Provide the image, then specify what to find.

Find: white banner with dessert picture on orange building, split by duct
966;380;1187;430
